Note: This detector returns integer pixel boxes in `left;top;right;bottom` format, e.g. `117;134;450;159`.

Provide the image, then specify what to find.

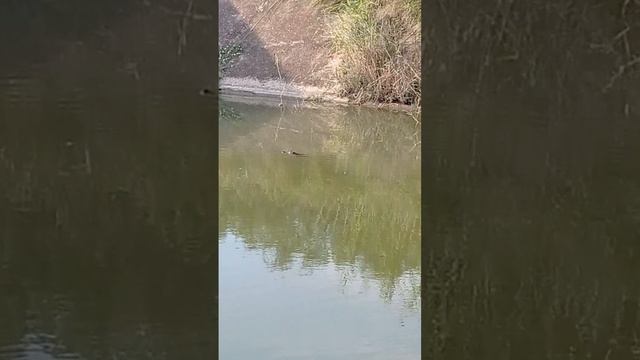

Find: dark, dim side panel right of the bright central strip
423;0;640;360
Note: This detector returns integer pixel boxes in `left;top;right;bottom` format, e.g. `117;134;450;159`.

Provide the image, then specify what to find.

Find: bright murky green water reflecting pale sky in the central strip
219;95;421;360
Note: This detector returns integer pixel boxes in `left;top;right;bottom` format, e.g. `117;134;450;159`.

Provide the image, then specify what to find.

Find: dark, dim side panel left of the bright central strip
0;0;217;359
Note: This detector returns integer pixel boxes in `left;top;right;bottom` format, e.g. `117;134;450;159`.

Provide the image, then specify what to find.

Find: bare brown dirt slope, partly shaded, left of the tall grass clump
218;0;333;88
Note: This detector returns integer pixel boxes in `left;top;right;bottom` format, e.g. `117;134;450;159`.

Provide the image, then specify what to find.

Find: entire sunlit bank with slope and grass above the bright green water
219;0;421;113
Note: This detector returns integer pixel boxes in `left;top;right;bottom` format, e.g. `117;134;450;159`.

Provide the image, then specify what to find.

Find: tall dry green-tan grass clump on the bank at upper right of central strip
316;0;421;105
